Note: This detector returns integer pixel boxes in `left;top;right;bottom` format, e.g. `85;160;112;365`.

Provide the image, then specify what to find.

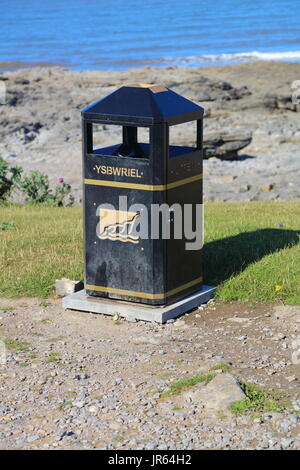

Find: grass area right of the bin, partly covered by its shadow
203;202;300;304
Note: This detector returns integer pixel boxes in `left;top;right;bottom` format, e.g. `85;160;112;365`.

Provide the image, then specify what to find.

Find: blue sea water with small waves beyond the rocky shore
0;0;300;70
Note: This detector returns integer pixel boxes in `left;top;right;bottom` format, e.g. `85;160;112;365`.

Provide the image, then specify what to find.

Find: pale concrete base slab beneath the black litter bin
62;286;216;323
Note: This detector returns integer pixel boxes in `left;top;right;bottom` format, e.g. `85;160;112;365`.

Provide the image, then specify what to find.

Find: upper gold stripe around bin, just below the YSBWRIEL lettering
84;174;202;191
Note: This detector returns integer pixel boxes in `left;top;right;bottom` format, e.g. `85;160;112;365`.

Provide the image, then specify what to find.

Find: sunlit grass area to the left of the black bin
0;205;83;298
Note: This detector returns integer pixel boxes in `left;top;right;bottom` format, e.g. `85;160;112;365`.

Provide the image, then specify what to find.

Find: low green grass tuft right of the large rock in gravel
229;382;291;415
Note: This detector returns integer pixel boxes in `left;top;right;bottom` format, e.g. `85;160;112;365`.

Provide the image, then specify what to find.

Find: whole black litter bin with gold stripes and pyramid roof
82;84;203;305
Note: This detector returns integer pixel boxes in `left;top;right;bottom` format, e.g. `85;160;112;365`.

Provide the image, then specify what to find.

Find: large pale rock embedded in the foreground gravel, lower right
186;374;246;412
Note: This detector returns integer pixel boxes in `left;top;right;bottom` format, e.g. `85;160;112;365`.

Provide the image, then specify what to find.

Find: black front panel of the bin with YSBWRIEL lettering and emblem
84;154;166;305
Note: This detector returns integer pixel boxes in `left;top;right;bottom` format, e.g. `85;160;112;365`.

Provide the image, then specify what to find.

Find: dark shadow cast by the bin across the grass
203;228;300;285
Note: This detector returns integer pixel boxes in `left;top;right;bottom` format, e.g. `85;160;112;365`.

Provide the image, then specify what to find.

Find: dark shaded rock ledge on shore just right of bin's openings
203;132;252;160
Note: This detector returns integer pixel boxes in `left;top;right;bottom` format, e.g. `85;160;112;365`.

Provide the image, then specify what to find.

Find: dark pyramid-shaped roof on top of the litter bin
82;84;204;125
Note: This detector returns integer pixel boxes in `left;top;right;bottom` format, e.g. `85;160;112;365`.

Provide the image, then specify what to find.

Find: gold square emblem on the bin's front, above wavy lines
98;209;139;243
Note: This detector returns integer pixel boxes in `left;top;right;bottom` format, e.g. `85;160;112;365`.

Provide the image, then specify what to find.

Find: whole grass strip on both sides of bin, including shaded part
0;202;300;304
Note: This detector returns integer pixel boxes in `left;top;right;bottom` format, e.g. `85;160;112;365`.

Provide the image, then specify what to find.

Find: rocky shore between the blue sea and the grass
0;62;300;202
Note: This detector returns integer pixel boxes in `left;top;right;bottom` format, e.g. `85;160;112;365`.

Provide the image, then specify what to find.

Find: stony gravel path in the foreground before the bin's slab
0;298;300;450
